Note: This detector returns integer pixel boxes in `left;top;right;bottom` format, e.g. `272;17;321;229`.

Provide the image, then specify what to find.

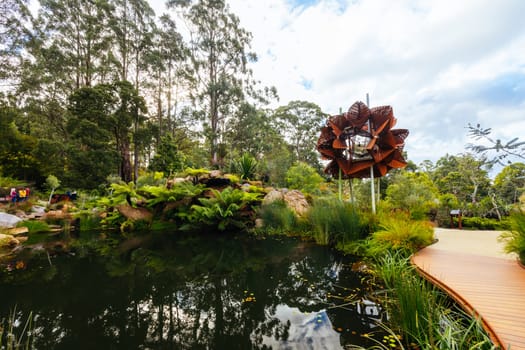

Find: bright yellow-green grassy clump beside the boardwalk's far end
368;212;434;256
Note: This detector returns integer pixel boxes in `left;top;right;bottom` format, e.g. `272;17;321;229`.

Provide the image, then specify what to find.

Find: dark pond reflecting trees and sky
0;233;382;350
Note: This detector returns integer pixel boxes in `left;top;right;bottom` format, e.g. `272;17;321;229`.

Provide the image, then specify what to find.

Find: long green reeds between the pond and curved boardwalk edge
374;253;495;350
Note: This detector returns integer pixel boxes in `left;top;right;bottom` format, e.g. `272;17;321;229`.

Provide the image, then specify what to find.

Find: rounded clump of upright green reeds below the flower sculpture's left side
308;198;363;246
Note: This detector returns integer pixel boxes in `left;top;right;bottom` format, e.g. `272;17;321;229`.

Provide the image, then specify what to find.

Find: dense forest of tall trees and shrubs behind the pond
0;0;525;223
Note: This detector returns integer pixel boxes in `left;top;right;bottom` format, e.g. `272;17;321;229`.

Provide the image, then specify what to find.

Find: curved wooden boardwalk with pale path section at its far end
412;229;525;350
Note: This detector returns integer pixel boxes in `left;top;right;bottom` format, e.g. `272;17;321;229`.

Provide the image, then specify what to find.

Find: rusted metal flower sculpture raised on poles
317;102;408;178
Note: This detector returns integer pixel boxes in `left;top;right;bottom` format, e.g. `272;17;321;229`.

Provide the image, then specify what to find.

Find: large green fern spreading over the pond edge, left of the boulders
189;187;260;231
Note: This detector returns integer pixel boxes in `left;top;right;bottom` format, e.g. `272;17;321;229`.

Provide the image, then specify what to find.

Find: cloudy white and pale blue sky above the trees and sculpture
156;0;525;164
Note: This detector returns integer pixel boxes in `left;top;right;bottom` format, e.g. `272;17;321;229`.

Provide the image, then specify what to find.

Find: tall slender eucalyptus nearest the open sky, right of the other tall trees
167;0;256;165
